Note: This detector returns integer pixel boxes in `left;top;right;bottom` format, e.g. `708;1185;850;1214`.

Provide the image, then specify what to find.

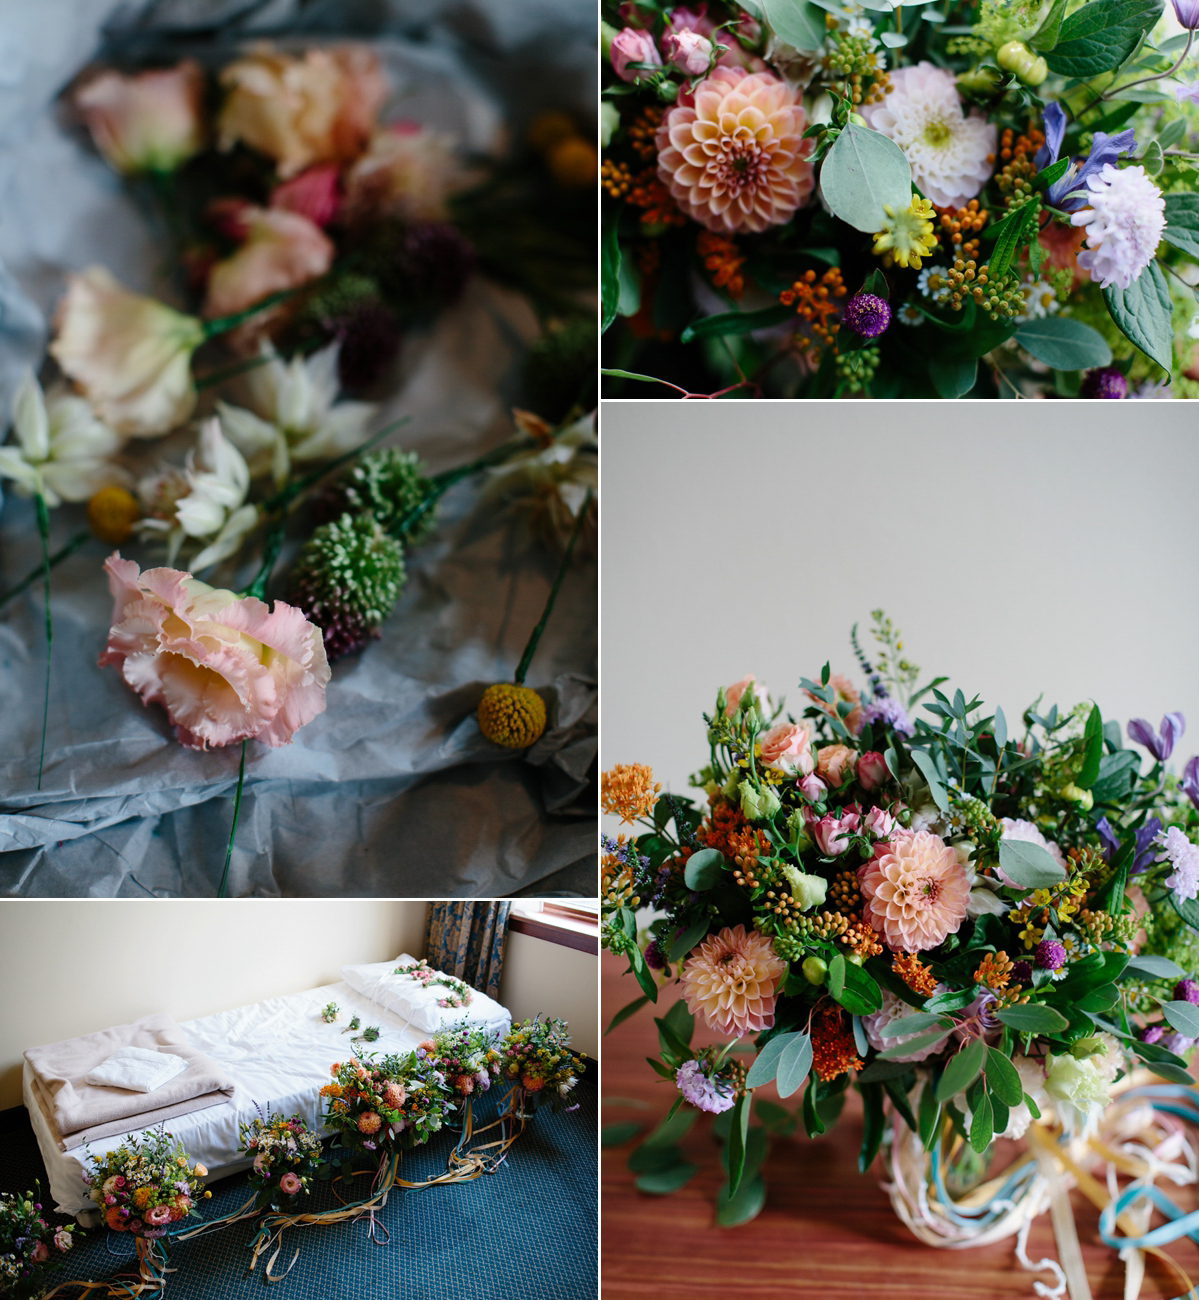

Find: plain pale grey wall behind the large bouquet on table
601;402;1199;806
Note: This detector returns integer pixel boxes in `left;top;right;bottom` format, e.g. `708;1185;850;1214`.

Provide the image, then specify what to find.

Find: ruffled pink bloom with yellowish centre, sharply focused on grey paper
100;553;329;749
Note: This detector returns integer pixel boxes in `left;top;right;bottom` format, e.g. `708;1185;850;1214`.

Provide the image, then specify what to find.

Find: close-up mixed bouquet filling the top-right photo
601;0;1199;398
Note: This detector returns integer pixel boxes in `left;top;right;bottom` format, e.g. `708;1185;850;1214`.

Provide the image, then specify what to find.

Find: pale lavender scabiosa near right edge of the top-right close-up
1070;163;1165;289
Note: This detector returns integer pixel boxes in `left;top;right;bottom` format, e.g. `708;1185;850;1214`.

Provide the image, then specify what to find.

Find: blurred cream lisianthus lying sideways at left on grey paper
49;267;204;438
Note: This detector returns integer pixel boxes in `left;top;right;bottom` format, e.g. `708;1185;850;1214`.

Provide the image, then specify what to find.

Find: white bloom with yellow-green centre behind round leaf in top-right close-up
862;62;996;208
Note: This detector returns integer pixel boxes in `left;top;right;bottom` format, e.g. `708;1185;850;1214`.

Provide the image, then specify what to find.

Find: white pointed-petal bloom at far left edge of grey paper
0;371;130;508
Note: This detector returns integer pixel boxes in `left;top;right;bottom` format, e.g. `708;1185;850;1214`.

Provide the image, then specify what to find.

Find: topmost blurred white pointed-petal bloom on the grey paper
217;343;376;485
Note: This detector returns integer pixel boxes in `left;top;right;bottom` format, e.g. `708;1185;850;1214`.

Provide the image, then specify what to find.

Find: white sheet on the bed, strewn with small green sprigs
23;982;511;1214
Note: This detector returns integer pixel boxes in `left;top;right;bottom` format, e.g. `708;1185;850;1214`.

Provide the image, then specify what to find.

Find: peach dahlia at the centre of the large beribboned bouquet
858;831;970;953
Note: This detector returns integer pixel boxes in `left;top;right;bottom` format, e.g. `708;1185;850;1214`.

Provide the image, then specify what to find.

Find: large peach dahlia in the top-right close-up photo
655;68;815;234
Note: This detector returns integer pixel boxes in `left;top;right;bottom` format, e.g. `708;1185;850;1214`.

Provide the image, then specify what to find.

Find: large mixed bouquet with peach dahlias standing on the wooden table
602;611;1199;1213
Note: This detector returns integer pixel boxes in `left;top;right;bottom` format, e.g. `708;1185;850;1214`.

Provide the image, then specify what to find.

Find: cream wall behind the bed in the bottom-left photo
0;898;598;1109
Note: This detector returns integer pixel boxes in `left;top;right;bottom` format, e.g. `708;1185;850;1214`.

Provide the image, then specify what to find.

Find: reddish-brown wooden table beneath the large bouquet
601;953;1199;1300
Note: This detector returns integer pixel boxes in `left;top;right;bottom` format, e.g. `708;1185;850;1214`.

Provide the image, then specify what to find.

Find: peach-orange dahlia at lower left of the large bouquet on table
680;926;787;1037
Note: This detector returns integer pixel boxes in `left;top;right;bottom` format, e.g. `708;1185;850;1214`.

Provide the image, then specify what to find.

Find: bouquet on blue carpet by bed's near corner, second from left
83;1125;212;1240
